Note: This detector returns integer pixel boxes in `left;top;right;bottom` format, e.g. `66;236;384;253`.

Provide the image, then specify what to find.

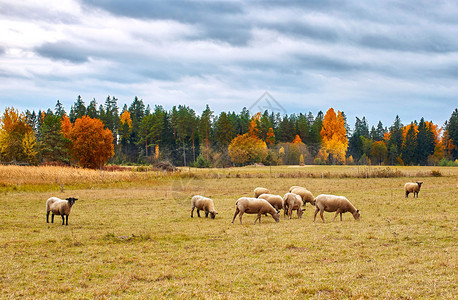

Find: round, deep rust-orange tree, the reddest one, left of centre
70;116;114;169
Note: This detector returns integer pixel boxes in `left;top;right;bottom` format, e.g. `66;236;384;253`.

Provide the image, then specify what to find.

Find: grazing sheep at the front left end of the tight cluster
232;197;280;224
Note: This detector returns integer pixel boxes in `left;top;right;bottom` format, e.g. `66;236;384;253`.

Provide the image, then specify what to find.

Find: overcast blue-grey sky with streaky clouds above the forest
0;0;458;127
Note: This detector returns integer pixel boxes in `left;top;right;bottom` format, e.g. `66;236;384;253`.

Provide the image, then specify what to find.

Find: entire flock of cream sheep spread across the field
46;181;423;225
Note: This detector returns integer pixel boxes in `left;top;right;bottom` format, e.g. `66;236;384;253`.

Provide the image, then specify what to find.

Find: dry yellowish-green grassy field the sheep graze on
0;166;458;299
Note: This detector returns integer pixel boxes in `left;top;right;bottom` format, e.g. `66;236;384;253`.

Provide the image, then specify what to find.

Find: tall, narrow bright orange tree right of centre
320;107;348;163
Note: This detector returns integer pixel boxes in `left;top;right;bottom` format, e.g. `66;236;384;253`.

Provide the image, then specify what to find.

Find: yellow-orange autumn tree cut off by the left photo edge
0;107;36;163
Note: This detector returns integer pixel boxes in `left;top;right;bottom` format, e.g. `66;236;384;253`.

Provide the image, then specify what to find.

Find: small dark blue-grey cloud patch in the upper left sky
34;41;89;64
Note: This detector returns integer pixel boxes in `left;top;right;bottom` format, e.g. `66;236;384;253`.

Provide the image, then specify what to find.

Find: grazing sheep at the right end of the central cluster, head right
313;194;361;223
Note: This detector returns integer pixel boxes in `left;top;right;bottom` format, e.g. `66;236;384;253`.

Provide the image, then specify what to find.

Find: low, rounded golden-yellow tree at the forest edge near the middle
229;132;267;164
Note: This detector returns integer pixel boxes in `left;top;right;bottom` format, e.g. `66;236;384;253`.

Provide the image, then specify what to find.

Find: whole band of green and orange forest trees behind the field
0;96;458;169
